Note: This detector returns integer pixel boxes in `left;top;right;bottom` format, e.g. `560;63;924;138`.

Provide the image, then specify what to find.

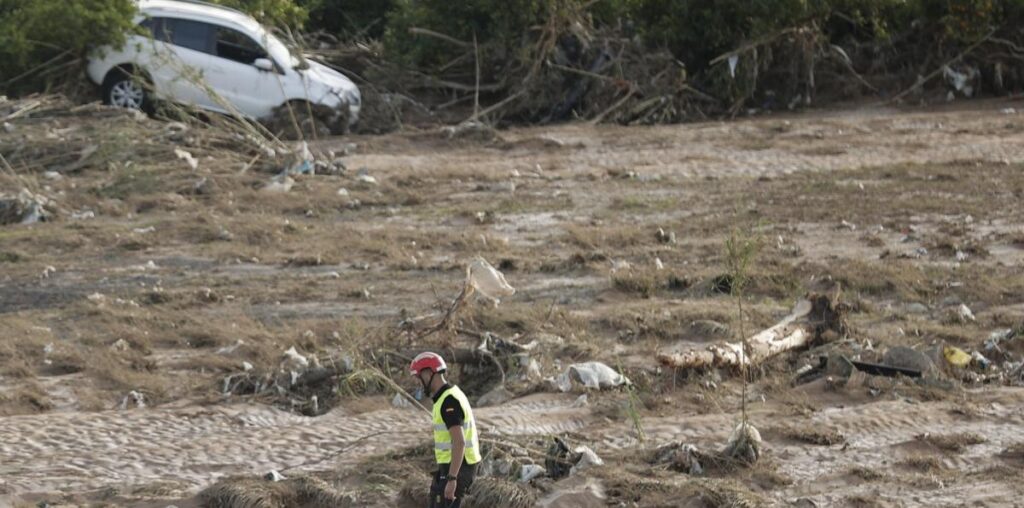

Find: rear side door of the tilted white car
155;17;223;111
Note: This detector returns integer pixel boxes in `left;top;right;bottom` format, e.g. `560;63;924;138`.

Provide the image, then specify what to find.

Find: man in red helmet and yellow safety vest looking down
409;352;480;508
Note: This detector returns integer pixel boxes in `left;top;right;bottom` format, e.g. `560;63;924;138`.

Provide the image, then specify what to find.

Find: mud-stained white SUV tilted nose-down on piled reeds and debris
87;0;360;133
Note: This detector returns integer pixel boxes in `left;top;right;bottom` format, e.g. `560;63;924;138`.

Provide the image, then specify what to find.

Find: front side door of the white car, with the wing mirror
201;26;285;118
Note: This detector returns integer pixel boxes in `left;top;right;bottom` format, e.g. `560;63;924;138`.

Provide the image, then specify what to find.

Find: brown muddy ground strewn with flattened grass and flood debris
0;97;1024;507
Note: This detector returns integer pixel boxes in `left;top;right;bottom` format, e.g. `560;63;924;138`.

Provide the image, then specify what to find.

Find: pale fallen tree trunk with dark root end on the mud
657;295;846;369
